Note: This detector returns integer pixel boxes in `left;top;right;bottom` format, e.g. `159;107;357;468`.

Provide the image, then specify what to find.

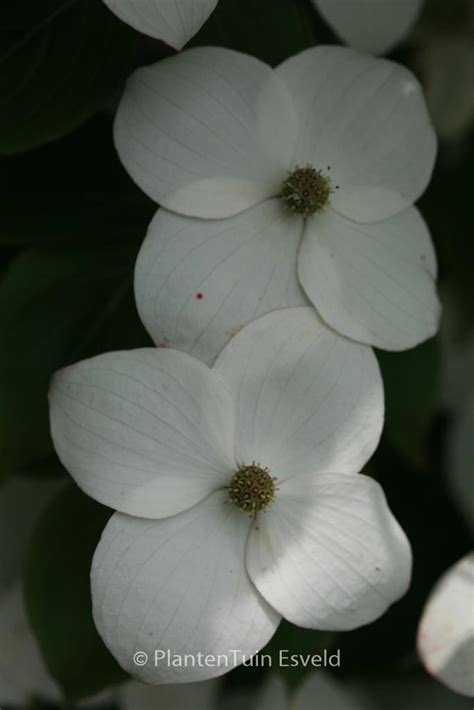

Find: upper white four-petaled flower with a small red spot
115;47;439;362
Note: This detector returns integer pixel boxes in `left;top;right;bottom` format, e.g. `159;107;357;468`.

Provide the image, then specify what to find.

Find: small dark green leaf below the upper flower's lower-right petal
377;339;439;466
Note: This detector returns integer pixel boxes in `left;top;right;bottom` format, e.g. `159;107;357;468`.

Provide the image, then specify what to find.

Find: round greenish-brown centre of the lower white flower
227;461;276;516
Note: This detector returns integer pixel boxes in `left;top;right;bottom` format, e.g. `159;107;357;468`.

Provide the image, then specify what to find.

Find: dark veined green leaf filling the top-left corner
0;0;138;155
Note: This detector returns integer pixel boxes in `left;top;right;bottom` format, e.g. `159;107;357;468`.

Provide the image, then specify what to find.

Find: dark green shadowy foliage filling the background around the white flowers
0;0;474;707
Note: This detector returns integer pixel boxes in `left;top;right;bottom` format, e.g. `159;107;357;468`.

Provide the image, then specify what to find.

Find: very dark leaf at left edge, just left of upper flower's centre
0;118;156;246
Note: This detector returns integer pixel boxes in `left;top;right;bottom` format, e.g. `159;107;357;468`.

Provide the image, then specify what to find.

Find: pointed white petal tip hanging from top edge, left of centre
104;0;218;49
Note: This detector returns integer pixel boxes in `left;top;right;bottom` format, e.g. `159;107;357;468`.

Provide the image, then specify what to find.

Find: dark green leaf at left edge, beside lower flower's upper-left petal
0;246;149;484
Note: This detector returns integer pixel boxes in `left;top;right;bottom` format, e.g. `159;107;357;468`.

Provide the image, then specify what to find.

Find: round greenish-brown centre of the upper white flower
280;165;337;217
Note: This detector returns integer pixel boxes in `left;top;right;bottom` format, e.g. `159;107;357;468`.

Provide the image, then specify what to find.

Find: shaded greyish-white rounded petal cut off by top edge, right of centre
313;0;423;54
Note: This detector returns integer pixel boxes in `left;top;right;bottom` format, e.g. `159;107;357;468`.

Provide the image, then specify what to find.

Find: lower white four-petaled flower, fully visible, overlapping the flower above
50;308;411;683
